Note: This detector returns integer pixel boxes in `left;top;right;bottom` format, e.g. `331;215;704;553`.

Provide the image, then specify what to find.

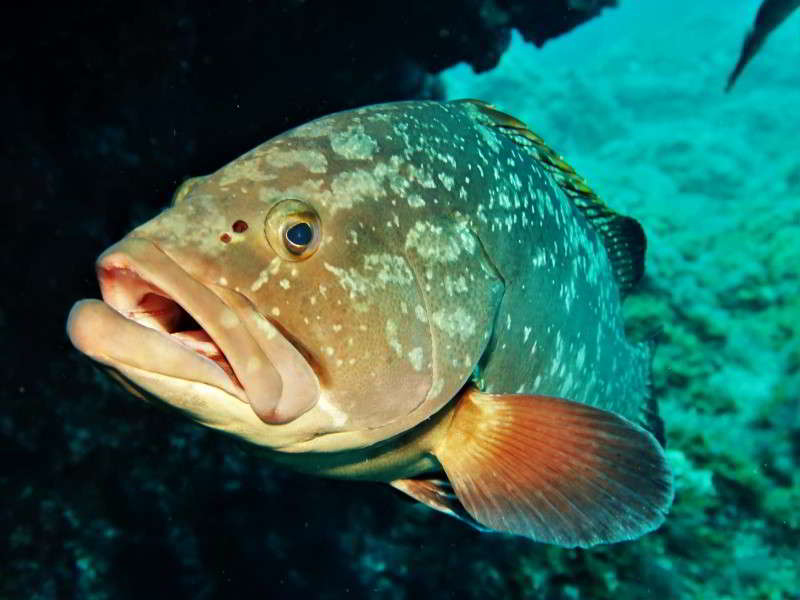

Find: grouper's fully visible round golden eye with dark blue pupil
264;199;322;261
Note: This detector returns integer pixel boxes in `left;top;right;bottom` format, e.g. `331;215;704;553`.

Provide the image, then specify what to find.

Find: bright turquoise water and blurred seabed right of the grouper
444;0;800;599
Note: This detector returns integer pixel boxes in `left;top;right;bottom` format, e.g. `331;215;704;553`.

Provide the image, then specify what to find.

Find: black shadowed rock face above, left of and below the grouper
0;0;613;598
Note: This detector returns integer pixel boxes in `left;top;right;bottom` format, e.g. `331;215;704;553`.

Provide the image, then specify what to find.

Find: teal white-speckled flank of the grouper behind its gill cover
444;105;650;420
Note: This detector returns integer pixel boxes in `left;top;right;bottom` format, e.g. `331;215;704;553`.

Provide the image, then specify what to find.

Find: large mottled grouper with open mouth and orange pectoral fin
67;101;672;546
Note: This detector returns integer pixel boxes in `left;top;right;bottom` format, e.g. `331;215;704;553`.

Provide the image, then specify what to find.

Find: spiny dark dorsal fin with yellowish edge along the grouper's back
456;99;647;296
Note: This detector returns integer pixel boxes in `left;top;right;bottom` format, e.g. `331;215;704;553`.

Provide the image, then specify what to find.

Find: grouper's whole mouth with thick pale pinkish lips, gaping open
67;238;318;424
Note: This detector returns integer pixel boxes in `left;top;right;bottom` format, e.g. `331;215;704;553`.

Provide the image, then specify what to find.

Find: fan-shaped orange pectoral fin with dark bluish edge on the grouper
434;389;673;547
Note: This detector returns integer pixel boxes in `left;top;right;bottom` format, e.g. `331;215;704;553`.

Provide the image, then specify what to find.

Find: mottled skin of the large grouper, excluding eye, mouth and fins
70;102;649;460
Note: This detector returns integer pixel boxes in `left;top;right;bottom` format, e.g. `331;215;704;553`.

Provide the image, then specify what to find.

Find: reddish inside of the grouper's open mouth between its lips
98;264;244;389
